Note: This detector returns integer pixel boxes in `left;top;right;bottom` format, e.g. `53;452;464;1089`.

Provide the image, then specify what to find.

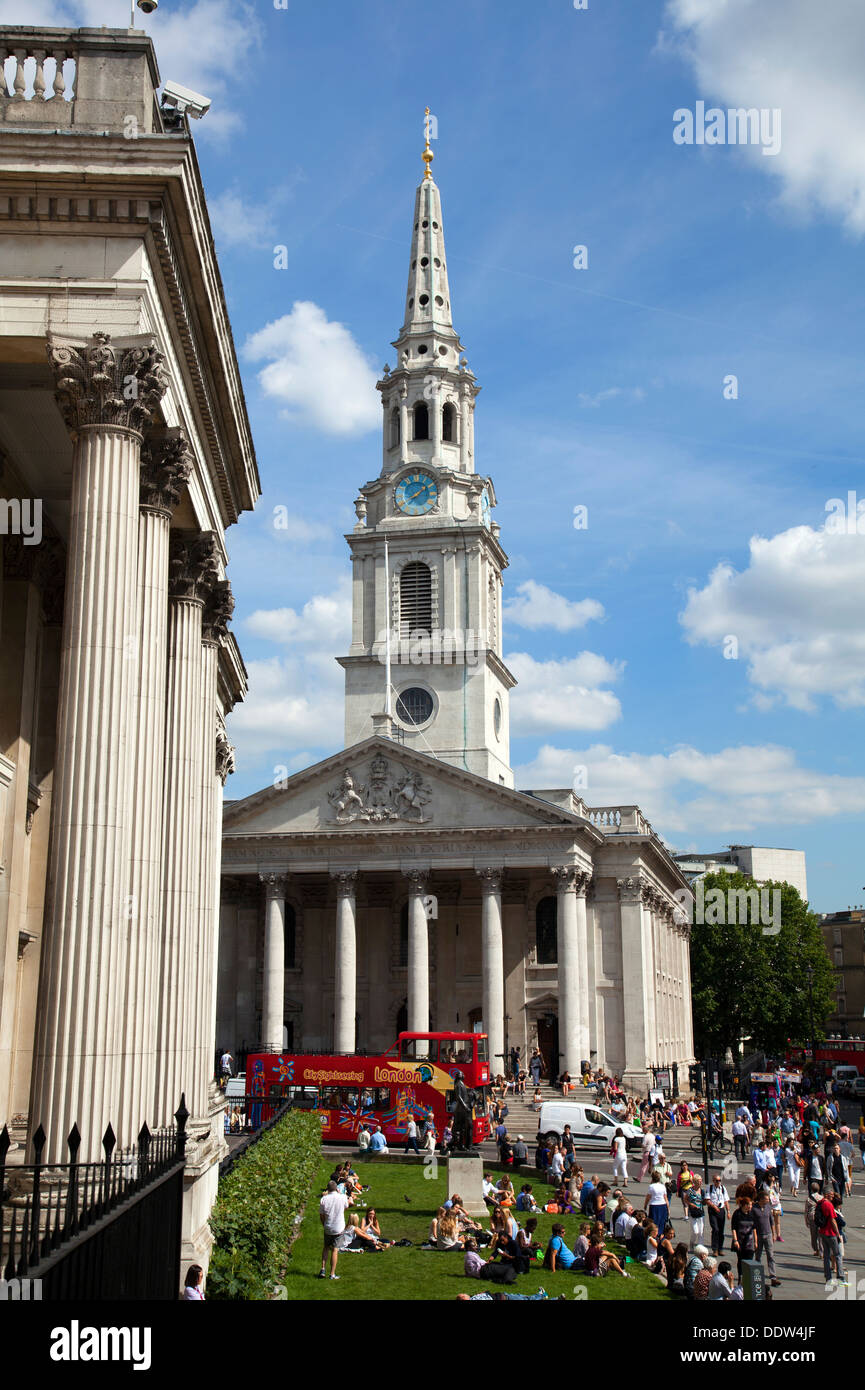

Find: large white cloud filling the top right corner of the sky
659;0;865;236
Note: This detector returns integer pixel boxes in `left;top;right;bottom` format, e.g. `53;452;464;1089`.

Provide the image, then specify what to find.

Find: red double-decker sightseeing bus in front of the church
246;1033;490;1144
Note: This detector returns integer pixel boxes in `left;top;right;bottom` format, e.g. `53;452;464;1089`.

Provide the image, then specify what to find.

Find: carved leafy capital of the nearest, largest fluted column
47;334;168;434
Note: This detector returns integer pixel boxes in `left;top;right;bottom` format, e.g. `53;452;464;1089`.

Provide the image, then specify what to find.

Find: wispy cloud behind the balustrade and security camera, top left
0;0;261;138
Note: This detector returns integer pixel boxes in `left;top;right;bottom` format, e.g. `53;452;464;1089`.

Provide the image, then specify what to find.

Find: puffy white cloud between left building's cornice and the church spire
245;300;381;435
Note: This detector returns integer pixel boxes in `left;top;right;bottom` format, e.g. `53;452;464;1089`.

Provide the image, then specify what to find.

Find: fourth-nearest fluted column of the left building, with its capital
186;580;233;1116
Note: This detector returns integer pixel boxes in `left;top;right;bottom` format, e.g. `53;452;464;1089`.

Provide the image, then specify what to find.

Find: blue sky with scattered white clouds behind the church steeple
25;0;865;910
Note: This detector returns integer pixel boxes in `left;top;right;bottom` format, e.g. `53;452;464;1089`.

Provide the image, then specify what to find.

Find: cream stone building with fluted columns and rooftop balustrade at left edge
0;28;259;1259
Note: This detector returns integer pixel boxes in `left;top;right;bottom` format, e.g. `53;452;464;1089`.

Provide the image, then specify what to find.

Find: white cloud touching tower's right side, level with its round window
505;652;624;737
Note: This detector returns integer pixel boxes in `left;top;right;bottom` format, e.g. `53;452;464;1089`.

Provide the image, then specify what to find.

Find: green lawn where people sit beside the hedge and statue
285;1156;672;1301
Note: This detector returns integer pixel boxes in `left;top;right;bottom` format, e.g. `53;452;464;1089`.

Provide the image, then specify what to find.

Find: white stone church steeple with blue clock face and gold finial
339;122;516;787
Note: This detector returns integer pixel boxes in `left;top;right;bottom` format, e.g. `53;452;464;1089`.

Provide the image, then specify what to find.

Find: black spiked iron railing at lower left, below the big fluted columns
0;1097;189;1300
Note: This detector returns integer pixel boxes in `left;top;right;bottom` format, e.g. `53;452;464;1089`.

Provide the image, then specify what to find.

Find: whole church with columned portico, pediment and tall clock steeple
217;145;694;1090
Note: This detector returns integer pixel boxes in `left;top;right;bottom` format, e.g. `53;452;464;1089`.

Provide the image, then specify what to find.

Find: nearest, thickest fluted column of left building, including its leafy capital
31;334;167;1162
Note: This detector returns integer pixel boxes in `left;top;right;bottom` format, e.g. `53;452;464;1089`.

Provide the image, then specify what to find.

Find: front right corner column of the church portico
551;865;591;1077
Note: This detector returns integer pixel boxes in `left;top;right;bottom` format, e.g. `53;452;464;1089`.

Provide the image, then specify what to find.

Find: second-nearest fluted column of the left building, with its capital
115;430;192;1143
